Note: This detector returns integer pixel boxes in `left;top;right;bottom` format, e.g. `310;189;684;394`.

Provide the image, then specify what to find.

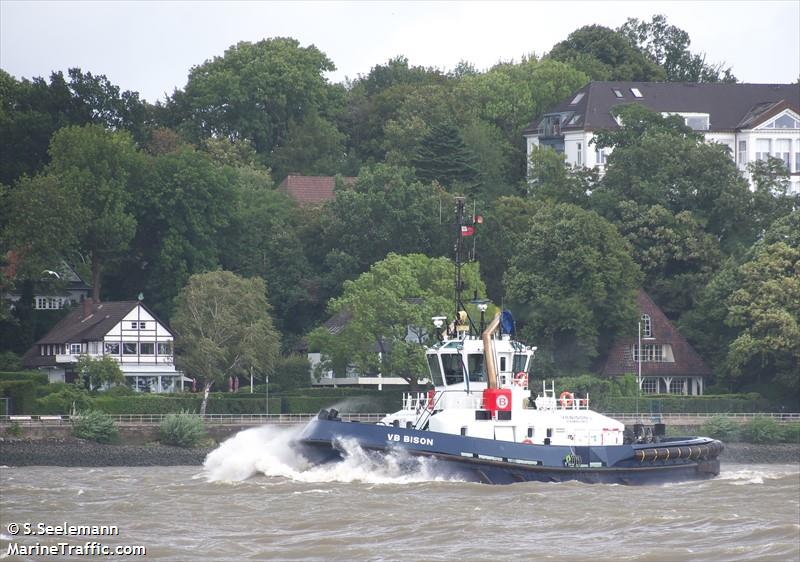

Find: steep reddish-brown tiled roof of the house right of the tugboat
600;291;711;376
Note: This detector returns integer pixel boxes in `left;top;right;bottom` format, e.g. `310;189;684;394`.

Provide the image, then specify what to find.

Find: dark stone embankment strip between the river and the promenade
0;438;800;467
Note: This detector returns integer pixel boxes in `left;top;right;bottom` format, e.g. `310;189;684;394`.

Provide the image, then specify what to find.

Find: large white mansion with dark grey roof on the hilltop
523;82;800;193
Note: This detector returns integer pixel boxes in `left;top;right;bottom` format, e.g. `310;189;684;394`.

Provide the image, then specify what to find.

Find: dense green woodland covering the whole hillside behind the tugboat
0;16;800;395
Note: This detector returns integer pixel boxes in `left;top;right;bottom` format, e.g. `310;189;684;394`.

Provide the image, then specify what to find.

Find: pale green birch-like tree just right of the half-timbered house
172;271;280;414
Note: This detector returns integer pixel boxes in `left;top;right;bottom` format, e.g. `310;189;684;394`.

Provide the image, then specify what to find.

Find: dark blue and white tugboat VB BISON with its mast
296;199;723;484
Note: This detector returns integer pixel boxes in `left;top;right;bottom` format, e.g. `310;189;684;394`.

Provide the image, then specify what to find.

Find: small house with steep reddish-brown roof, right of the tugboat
601;291;711;395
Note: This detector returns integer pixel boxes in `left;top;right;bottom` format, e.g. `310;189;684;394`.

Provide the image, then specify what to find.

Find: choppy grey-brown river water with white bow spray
0;427;800;562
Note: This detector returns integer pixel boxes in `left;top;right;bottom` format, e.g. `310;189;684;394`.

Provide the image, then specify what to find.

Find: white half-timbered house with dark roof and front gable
23;299;185;392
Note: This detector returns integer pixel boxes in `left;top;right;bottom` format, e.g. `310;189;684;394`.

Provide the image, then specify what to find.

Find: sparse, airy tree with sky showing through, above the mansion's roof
617;14;736;82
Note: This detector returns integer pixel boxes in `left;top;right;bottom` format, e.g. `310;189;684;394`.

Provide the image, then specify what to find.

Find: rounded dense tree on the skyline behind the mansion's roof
547;25;666;82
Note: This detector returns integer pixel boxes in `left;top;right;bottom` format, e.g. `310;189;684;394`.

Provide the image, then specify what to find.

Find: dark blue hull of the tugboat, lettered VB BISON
297;419;723;484
